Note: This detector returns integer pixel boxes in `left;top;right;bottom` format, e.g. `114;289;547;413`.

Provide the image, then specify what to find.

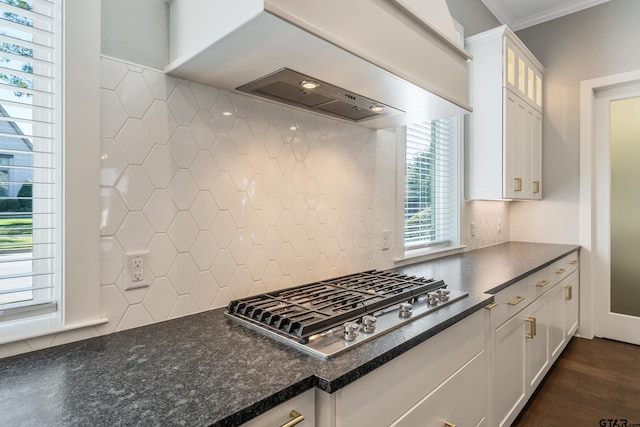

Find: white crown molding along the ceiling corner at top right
482;0;610;31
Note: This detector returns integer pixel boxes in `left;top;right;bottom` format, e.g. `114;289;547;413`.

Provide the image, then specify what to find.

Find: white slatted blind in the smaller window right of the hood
404;118;458;251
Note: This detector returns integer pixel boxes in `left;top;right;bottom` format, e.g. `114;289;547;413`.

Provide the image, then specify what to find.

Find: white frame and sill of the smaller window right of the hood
394;115;464;263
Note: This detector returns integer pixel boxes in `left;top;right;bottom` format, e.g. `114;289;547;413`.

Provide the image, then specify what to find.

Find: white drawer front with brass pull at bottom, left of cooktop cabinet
242;389;316;427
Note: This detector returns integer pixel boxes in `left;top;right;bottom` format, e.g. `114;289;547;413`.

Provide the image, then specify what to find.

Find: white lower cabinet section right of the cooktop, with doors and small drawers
487;254;579;426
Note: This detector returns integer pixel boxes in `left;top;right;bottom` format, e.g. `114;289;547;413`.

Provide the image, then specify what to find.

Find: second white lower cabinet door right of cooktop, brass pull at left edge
523;296;549;390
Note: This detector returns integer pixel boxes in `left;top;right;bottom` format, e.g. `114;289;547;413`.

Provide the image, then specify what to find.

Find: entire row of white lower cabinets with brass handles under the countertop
245;252;580;427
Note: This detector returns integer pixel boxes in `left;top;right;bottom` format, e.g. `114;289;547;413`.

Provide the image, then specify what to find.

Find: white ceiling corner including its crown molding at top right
482;0;610;31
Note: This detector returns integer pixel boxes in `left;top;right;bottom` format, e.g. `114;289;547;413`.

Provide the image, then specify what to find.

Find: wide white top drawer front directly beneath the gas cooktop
335;310;488;427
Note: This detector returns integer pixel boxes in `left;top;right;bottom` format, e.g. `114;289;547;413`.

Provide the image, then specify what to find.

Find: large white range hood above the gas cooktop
165;0;471;129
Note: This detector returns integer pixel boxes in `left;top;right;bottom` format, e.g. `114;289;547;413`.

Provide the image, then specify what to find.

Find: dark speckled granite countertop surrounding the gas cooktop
0;243;578;426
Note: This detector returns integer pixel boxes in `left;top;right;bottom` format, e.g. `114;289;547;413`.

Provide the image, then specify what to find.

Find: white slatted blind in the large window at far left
0;0;61;322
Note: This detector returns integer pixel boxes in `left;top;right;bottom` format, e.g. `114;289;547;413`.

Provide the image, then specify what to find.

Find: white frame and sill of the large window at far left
0;0;102;344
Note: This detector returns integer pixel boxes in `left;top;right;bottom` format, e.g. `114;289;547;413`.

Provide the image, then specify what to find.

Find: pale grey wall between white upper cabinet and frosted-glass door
510;0;640;243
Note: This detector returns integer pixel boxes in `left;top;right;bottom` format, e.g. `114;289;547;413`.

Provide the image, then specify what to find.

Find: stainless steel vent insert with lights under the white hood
236;68;403;123
